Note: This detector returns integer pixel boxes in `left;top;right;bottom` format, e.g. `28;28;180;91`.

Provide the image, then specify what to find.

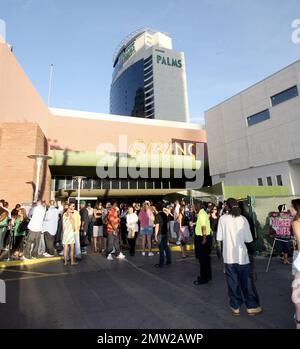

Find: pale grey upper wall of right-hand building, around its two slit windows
205;61;300;177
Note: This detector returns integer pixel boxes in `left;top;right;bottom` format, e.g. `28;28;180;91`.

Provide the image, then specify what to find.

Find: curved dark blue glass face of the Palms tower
110;59;145;117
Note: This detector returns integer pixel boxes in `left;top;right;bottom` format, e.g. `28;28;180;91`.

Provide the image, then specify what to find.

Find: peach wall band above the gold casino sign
48;110;206;151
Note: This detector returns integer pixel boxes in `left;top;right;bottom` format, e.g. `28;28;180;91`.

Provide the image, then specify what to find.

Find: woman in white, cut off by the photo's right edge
291;199;300;330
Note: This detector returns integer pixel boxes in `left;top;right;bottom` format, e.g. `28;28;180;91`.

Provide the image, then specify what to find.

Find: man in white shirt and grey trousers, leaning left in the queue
24;200;46;259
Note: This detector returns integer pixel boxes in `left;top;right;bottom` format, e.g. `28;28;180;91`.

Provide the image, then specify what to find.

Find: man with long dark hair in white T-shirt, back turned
217;198;262;315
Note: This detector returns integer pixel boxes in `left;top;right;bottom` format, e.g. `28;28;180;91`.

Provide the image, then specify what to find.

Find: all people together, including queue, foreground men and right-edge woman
0;198;300;328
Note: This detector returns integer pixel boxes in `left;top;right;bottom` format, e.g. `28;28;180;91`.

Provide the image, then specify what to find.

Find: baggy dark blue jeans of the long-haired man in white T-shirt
225;263;259;309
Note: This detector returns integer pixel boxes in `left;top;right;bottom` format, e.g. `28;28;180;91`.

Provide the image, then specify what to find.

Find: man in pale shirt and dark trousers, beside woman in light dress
42;200;59;257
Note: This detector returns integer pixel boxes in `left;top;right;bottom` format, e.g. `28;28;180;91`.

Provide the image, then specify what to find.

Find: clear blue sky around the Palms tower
0;0;300;123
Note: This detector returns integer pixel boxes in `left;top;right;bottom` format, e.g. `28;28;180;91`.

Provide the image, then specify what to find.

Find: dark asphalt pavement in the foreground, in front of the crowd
0;252;294;329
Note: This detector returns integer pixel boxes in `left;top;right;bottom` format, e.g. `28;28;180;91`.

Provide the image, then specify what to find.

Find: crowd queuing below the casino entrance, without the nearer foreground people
0;200;195;265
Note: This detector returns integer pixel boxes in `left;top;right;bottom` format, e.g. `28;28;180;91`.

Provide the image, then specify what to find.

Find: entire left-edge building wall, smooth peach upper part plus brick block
0;43;51;208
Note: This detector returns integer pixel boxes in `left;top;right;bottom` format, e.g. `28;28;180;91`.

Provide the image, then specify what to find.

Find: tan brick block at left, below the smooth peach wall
0;123;51;209
